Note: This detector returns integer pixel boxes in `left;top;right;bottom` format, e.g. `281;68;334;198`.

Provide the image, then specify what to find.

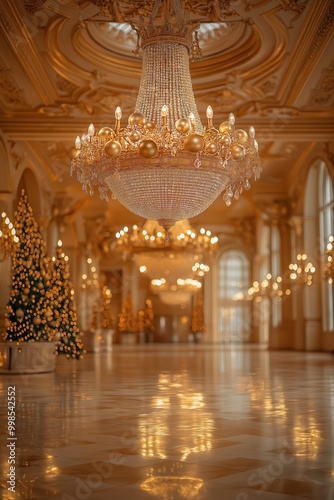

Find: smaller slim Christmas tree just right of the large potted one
53;241;84;359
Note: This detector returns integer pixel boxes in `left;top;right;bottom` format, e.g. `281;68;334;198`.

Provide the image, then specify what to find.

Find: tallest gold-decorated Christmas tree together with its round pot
0;191;56;373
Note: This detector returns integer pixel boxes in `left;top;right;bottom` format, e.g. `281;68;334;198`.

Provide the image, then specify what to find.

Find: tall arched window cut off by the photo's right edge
319;162;334;331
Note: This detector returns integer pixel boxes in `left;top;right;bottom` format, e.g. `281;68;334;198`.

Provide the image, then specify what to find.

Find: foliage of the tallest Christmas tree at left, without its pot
4;191;55;344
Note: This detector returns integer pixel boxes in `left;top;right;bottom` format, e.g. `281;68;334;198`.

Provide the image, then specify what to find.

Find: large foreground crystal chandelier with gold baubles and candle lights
71;0;261;231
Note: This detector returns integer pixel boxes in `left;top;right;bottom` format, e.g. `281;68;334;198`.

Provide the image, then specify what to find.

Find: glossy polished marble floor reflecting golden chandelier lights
0;344;334;500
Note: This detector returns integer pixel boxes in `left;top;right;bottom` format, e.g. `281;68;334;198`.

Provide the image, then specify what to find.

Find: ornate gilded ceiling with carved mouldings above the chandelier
0;0;334;229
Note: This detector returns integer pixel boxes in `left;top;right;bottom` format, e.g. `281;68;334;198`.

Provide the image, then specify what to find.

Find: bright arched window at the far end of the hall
218;250;250;342
